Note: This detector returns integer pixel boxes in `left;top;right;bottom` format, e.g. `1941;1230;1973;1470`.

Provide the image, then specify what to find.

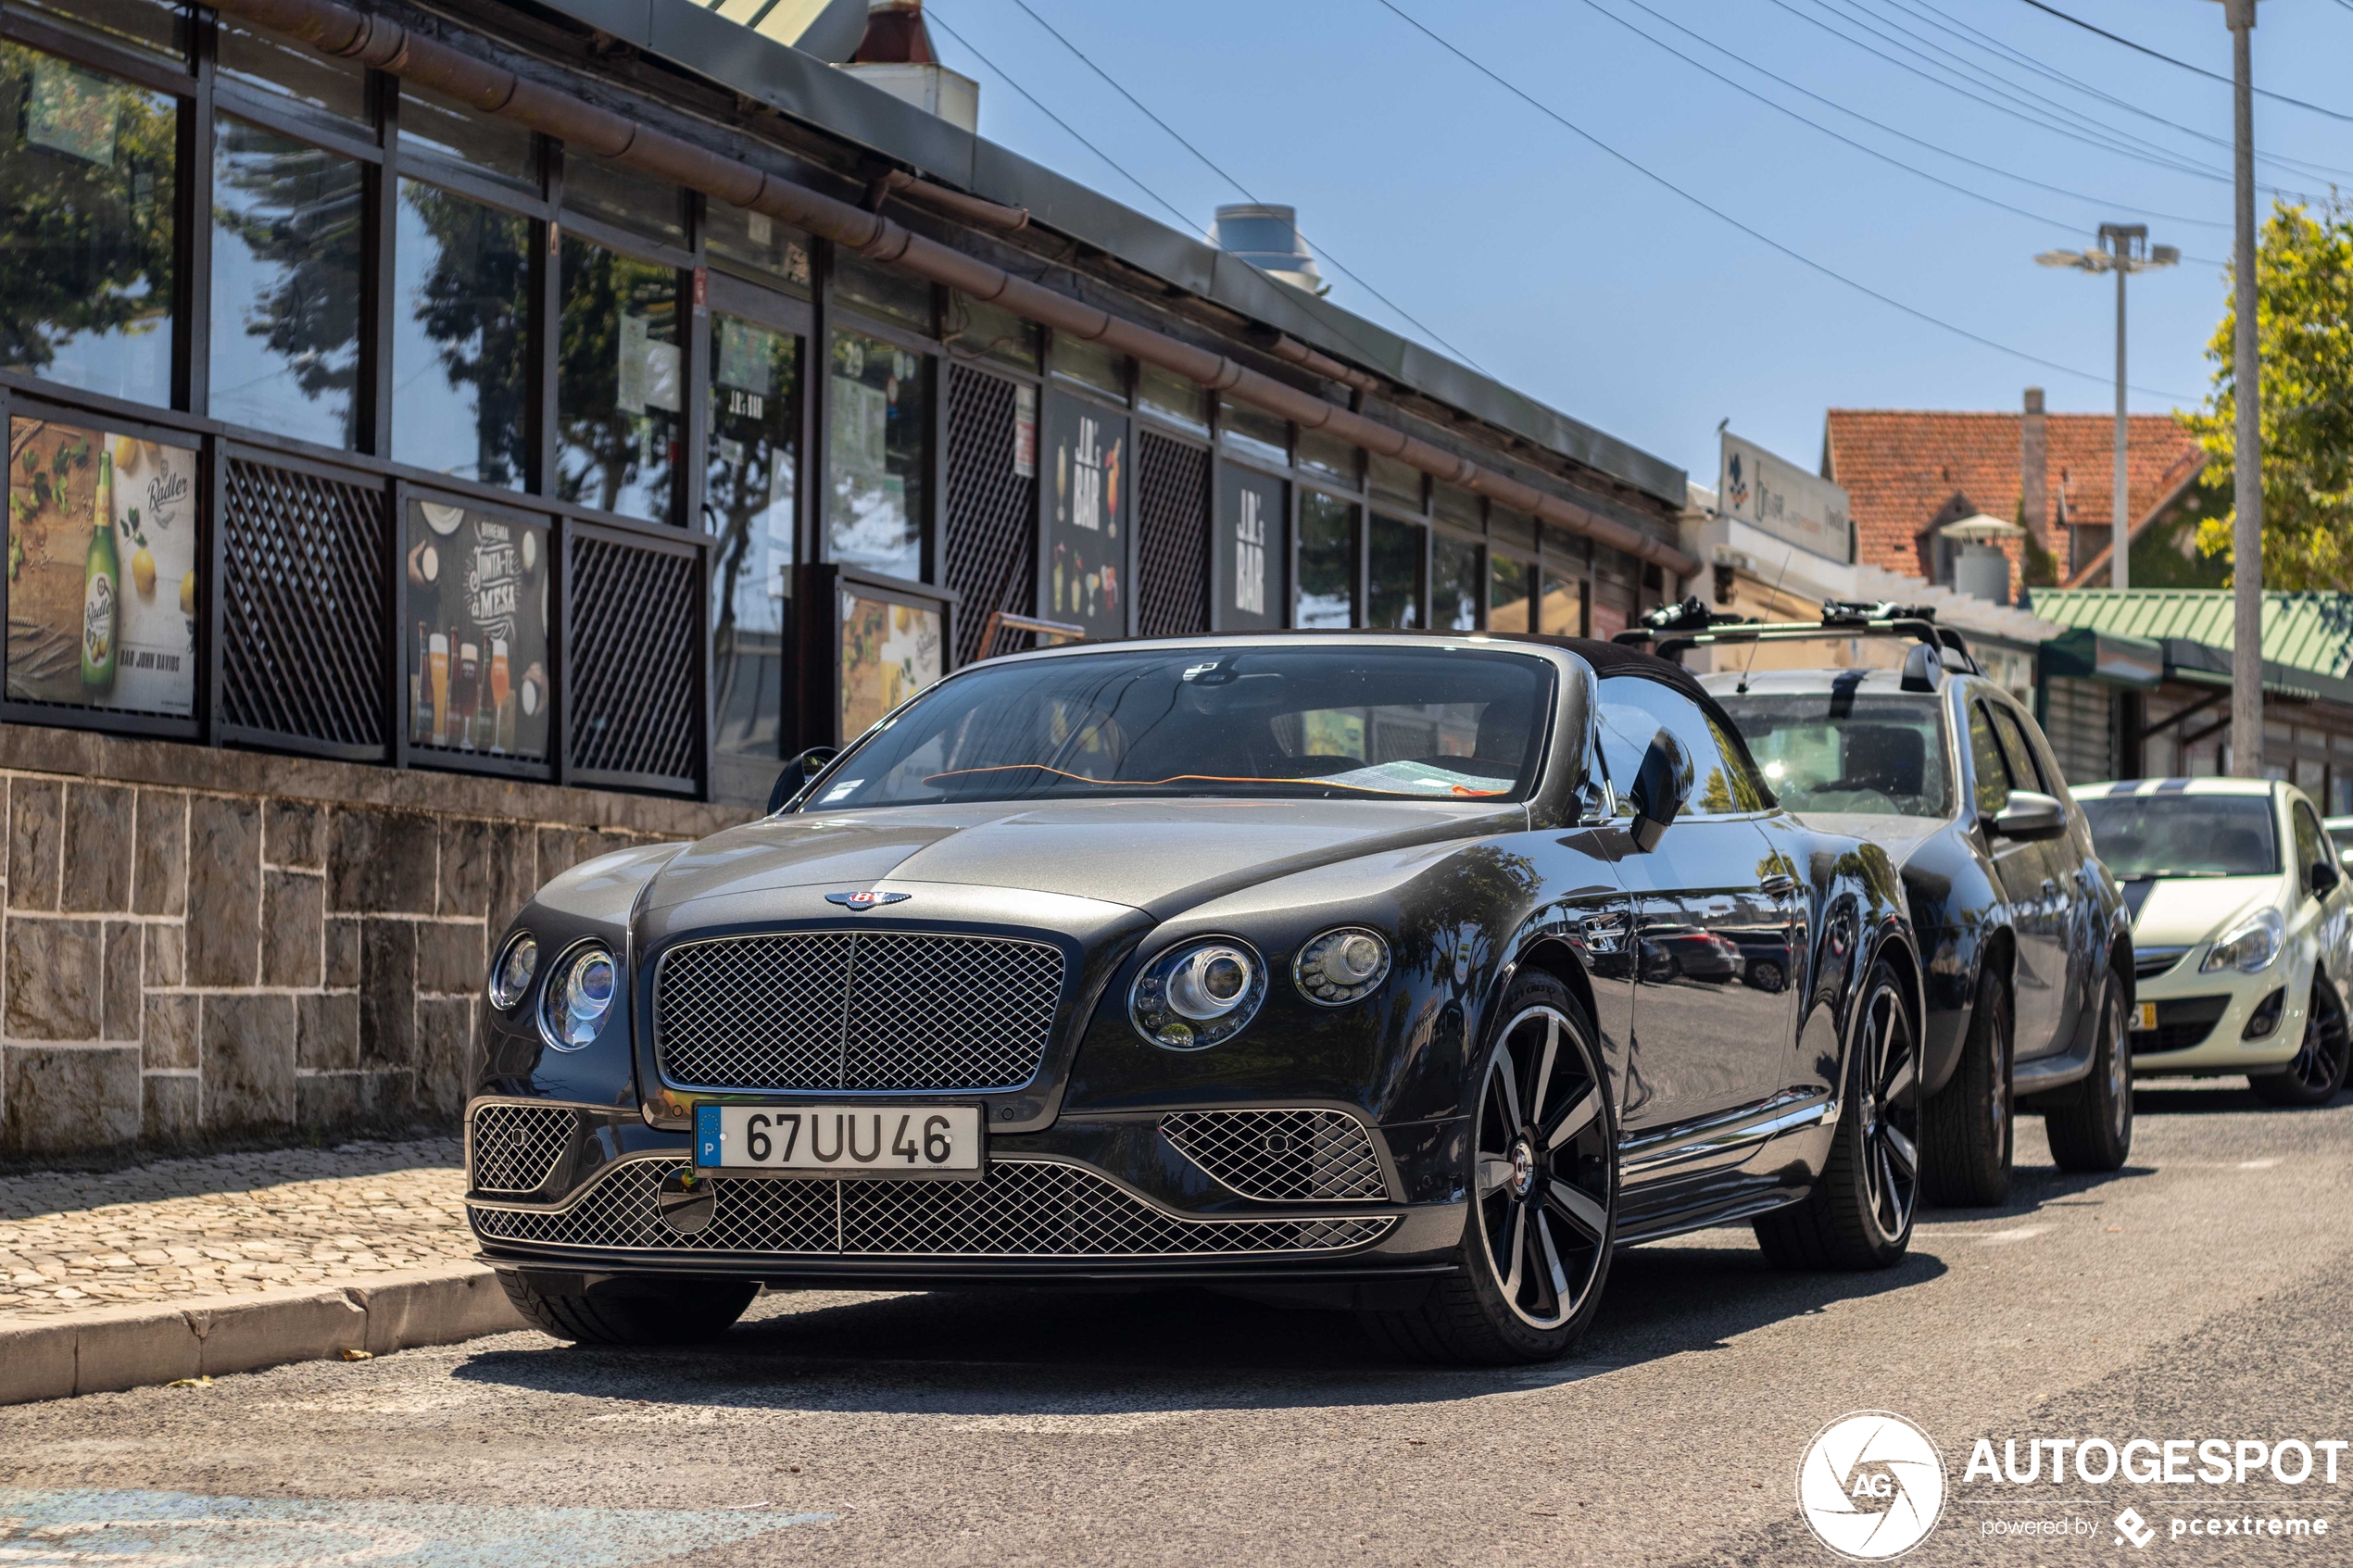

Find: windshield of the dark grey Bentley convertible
812;646;1553;809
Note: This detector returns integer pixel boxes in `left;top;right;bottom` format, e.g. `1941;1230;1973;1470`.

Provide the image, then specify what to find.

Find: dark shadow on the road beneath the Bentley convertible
454;1232;1946;1424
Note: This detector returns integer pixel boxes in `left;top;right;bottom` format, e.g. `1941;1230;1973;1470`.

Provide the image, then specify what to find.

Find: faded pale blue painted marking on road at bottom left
0;1488;836;1568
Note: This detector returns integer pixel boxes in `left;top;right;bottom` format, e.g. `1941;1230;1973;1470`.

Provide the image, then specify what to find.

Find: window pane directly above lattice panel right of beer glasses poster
555;235;683;521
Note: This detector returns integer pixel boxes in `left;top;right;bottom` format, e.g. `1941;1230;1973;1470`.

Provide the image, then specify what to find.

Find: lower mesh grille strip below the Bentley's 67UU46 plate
466;1157;1395;1258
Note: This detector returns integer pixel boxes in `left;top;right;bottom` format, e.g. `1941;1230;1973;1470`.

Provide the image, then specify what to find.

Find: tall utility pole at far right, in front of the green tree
2221;0;2263;778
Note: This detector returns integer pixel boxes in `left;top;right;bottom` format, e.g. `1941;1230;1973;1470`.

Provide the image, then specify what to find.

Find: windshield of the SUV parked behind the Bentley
1716;689;1953;818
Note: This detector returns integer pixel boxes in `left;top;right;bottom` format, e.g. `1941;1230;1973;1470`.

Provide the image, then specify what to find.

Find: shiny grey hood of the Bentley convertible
645;799;1527;917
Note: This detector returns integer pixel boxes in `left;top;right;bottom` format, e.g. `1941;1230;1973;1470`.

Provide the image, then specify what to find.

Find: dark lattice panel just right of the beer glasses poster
565;533;703;790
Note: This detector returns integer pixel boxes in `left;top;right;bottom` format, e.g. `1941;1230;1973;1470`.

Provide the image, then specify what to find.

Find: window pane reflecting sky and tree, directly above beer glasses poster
393;179;532;489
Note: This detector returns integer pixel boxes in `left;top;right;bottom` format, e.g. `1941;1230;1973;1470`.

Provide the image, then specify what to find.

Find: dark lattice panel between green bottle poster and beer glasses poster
221;451;386;757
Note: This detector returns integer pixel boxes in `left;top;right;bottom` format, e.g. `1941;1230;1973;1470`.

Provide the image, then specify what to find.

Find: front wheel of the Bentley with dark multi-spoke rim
1360;973;1617;1366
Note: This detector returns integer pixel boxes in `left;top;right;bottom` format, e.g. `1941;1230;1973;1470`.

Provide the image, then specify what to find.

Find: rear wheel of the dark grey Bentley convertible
1751;960;1920;1270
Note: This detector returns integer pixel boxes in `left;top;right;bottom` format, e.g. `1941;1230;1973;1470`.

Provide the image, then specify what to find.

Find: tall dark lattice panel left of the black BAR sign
949;364;1038;665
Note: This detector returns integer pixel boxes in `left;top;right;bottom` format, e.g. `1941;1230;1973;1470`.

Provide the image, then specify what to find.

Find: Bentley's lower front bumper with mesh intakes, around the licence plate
466;1100;1464;1284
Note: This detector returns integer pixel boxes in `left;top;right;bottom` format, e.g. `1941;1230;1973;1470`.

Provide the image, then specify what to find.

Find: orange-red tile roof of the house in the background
1824;409;2205;571
